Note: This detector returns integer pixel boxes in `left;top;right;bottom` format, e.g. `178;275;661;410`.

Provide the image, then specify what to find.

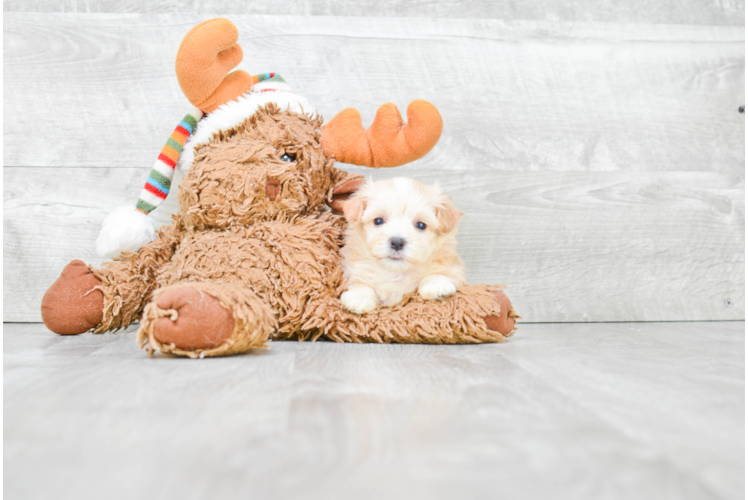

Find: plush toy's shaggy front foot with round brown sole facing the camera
138;282;278;358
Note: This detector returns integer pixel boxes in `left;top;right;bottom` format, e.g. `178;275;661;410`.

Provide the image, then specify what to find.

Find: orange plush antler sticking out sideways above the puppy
322;100;443;168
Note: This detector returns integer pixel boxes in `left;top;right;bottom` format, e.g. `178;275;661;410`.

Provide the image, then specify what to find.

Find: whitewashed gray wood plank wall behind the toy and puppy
3;0;748;322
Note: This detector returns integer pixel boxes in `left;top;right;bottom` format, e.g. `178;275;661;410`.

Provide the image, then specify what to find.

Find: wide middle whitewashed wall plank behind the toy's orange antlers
3;13;748;175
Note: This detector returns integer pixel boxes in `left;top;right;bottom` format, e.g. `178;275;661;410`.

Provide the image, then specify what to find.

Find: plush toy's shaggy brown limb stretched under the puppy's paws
302;285;519;344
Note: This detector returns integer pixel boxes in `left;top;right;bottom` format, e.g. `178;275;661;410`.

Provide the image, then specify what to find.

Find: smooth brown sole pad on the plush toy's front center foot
153;286;235;350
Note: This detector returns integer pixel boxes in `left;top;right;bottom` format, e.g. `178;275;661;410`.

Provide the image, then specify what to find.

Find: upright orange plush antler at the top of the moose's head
176;18;254;113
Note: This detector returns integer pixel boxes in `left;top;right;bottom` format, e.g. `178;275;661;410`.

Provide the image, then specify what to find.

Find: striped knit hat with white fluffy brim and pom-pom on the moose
96;73;311;257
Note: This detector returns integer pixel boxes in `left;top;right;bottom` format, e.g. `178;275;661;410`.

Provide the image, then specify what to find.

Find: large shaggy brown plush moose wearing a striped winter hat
42;19;517;357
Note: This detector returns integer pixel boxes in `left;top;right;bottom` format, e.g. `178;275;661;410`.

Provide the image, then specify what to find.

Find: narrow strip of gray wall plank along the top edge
3;0;748;25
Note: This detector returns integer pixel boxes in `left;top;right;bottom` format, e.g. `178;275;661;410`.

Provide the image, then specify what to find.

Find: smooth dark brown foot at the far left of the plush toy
42;260;104;335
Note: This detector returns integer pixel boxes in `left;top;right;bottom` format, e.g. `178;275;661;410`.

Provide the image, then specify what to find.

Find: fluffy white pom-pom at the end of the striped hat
96;206;156;257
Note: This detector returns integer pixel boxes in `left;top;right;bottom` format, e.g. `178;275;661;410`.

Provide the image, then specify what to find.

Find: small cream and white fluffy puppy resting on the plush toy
340;178;465;314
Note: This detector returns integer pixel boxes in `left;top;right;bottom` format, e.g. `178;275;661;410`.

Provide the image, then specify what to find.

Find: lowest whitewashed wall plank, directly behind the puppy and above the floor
3;166;748;322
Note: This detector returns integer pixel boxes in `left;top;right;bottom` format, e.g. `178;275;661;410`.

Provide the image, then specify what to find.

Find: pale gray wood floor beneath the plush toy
3;322;746;500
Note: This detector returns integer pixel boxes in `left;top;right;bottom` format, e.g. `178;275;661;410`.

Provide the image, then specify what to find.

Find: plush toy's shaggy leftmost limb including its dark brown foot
42;222;182;335
